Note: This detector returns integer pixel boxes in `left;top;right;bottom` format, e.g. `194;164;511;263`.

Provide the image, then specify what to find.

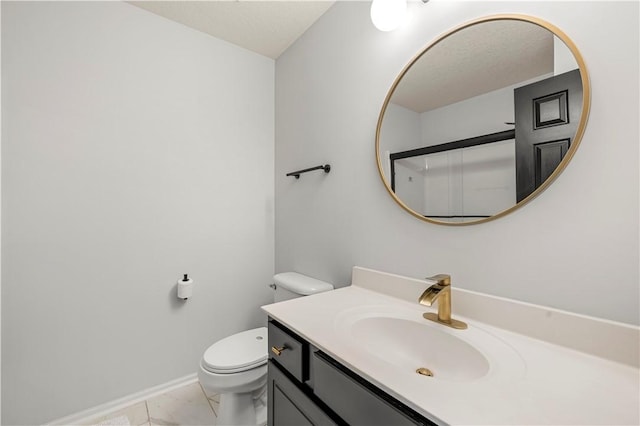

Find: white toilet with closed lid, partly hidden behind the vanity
198;272;333;426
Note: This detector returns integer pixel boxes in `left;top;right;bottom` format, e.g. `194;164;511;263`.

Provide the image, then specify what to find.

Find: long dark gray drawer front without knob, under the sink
313;351;435;426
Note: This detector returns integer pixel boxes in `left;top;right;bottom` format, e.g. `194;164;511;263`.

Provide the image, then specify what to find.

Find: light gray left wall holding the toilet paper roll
2;2;274;424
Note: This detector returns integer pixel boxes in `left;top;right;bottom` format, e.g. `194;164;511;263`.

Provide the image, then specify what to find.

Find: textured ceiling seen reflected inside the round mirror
391;21;554;113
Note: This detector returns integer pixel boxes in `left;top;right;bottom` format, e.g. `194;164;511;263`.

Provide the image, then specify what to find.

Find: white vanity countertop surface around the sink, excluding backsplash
263;276;640;425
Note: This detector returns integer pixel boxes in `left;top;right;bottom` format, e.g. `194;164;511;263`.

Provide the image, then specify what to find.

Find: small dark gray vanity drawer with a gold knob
268;321;309;382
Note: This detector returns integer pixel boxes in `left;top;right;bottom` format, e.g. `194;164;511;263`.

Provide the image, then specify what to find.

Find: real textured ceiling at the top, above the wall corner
128;0;334;59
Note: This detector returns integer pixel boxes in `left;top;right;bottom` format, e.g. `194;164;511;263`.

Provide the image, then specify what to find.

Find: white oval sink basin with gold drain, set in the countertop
335;306;524;382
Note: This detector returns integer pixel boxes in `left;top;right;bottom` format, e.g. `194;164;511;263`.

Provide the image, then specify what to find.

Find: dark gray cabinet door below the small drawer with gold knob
267;361;336;426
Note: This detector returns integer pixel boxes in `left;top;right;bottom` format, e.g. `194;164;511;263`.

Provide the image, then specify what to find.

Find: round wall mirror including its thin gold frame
376;15;590;225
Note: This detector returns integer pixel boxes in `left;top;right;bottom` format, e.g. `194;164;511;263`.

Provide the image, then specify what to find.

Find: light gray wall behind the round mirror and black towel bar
275;1;640;324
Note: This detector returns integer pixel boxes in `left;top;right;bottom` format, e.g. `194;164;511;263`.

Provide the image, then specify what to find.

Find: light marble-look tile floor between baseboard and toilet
85;382;220;426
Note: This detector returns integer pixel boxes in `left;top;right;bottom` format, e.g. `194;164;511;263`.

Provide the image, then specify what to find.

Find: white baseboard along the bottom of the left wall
46;373;198;426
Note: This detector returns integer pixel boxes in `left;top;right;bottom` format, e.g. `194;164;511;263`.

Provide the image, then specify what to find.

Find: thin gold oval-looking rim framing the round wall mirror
376;14;591;226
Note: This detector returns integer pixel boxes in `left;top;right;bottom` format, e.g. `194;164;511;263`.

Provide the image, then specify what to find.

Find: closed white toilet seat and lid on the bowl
202;327;268;374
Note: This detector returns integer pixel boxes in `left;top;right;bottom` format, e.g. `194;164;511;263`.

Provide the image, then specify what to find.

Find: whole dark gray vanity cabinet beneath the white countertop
268;320;435;426
